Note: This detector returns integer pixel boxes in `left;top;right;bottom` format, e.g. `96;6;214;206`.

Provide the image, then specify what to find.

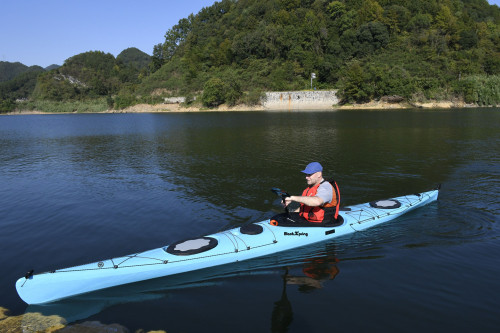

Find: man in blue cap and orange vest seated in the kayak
273;162;340;226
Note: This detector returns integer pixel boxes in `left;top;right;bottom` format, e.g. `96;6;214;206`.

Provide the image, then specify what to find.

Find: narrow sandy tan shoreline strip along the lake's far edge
2;101;488;115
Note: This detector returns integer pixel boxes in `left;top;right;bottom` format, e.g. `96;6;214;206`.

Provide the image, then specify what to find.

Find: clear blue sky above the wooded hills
0;0;500;67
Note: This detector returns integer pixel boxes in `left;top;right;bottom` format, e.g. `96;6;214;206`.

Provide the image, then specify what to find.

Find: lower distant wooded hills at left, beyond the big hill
0;47;151;107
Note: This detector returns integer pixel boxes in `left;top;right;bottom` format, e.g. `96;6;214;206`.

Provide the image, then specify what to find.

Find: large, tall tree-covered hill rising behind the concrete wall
141;0;500;102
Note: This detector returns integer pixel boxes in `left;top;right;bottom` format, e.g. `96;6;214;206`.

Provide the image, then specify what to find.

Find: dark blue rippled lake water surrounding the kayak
0;108;500;332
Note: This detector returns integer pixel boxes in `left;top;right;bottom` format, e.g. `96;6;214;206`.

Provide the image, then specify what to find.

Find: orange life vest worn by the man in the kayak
299;180;340;223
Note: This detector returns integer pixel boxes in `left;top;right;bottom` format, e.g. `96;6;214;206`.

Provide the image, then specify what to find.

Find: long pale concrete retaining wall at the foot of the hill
262;90;339;110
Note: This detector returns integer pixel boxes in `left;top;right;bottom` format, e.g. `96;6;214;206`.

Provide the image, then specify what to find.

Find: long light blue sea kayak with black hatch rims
16;188;439;304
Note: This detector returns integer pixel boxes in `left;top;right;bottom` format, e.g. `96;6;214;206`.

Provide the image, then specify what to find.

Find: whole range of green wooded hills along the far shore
0;0;500;111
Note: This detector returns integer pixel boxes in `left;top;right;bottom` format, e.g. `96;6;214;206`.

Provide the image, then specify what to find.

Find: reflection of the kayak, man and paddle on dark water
21;239;339;332
